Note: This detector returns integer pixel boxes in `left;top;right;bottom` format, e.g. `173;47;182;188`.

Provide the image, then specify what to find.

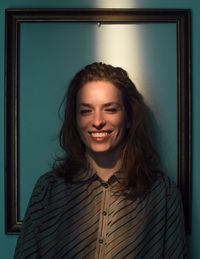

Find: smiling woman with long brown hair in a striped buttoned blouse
15;63;186;259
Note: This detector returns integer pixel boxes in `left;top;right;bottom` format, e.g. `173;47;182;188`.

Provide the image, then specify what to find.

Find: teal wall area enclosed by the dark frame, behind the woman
19;22;177;218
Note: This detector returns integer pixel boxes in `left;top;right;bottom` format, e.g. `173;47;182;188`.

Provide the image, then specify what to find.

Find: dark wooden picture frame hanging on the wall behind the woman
5;9;192;234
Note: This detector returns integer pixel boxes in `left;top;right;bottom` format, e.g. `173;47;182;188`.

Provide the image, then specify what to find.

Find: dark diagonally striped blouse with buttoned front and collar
14;172;187;259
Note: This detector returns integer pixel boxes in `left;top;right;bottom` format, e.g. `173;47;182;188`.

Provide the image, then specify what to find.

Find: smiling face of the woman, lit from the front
76;81;127;155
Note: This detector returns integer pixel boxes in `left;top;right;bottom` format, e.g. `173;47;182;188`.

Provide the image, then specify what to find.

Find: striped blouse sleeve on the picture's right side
163;180;187;259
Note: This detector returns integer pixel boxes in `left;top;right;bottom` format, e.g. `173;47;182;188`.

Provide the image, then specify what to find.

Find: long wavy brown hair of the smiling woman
53;62;162;196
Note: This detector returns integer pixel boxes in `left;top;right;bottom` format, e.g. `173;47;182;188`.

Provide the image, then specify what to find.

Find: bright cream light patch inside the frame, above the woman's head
96;23;144;94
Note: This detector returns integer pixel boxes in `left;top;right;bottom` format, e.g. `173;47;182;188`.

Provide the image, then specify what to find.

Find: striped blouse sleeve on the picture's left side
14;176;47;259
